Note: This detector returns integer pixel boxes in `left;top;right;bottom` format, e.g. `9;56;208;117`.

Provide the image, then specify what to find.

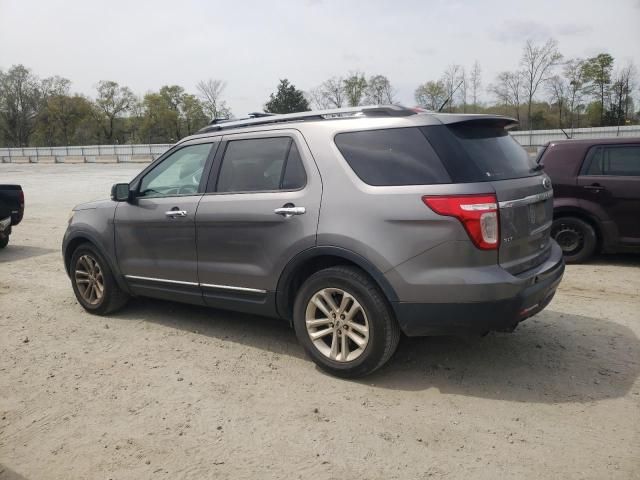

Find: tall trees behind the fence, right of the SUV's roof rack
415;39;640;130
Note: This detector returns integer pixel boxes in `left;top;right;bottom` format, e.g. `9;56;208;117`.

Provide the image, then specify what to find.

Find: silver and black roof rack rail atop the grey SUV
197;105;418;133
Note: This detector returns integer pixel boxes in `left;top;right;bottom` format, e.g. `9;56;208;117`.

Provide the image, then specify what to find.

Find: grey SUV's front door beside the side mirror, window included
115;140;220;303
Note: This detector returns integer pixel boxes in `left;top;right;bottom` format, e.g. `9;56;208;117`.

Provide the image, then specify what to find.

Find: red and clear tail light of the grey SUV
422;194;500;250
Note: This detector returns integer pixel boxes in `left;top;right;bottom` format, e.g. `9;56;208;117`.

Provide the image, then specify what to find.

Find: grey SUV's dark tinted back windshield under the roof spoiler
421;121;539;182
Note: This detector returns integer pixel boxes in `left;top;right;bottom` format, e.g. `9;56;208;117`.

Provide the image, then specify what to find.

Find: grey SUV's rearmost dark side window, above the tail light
335;128;451;186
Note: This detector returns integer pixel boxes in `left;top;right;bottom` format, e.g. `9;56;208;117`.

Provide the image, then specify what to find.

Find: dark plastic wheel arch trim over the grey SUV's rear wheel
276;246;398;321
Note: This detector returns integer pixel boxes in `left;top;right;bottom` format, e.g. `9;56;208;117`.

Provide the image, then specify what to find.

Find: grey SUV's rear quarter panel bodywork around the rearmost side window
304;119;497;273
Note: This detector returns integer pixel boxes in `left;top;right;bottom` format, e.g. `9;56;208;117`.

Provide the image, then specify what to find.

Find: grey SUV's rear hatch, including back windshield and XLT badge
423;120;553;274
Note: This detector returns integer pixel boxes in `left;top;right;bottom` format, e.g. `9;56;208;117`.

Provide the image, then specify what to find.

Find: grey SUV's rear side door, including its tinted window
196;130;322;313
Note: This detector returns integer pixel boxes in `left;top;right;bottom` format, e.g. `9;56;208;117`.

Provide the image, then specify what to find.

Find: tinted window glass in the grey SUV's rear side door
216;137;306;192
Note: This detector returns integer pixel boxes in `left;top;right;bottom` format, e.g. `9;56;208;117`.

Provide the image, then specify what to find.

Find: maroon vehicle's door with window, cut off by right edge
578;145;640;240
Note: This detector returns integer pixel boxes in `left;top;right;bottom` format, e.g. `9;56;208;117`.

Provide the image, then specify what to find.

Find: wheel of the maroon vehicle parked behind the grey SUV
551;217;598;263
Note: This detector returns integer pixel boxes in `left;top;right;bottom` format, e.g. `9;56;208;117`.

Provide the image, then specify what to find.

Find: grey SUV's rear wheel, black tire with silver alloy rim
293;266;400;378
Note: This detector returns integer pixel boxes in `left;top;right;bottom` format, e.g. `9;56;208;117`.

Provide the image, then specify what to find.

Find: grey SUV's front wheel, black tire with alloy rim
69;243;129;315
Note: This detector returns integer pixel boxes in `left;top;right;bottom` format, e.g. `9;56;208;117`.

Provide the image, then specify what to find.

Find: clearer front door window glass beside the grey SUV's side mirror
138;143;211;198
